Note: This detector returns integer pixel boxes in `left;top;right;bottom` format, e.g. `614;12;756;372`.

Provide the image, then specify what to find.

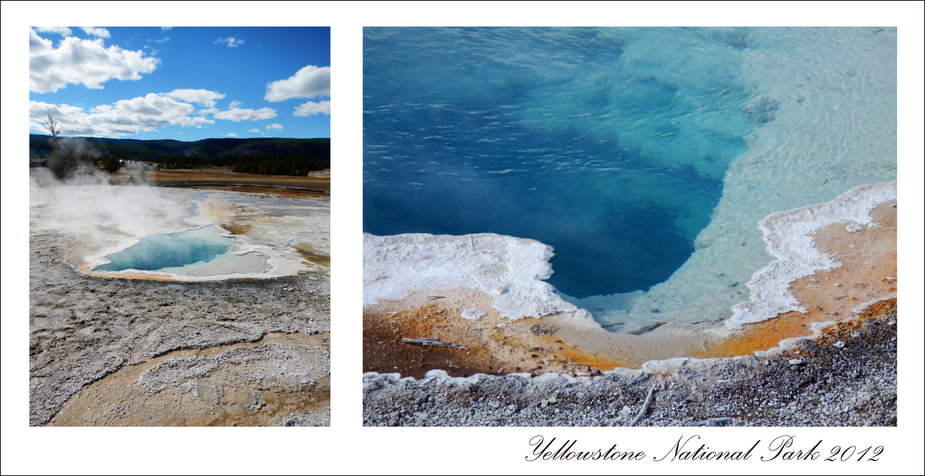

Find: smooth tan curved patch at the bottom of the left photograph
46;332;330;426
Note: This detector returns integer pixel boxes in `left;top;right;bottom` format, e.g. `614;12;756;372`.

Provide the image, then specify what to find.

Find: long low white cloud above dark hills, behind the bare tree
29;93;215;137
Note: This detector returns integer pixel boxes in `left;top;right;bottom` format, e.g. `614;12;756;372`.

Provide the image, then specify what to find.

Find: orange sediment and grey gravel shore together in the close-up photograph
364;200;897;426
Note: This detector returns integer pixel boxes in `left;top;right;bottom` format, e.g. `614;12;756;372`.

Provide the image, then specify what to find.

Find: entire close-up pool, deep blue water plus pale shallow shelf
363;28;896;330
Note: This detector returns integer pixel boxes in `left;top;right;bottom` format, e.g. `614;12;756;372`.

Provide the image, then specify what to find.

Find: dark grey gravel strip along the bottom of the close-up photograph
363;299;897;426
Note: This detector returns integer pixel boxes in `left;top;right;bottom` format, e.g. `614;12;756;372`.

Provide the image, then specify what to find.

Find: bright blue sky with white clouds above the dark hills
29;27;331;141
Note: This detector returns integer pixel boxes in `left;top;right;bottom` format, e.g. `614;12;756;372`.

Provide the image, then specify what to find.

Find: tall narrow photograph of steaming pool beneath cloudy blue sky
23;27;331;426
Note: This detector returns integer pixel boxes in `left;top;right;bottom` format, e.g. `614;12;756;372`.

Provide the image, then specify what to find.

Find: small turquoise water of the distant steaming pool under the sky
94;227;234;271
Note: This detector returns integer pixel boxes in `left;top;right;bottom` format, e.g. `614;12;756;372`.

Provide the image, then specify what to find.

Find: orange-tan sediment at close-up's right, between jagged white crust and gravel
691;200;897;357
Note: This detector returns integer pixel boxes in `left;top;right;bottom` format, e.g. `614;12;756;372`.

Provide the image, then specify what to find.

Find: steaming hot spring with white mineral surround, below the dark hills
29;184;330;281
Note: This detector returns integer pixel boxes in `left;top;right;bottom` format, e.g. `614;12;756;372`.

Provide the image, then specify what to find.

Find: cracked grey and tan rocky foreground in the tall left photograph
29;229;330;426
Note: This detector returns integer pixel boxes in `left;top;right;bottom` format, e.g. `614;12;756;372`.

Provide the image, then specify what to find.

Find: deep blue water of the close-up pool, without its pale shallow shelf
363;28;767;297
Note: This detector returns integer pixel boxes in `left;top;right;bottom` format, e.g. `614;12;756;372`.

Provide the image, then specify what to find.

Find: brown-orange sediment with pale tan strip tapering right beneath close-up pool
363;288;718;378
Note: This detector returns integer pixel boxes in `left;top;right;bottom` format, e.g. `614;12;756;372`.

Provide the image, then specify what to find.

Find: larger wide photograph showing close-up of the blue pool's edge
362;26;898;427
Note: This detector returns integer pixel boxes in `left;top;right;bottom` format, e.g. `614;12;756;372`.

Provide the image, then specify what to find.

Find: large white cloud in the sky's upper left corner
29;29;160;93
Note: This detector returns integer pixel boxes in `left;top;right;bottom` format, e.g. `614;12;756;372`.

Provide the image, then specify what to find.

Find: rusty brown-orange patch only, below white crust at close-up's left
363;288;620;378
